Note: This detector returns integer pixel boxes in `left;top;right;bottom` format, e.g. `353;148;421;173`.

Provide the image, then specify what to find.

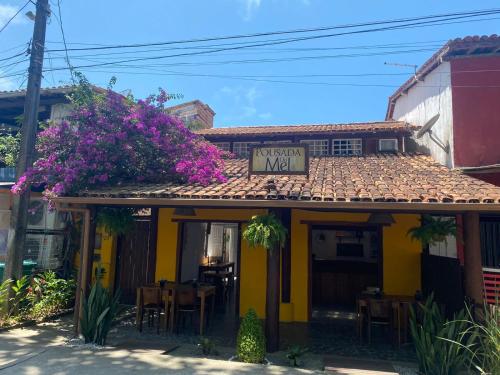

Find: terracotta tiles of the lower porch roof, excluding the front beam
80;154;500;204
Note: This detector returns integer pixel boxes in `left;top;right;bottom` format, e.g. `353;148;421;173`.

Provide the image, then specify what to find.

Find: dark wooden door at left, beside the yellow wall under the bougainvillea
115;217;156;304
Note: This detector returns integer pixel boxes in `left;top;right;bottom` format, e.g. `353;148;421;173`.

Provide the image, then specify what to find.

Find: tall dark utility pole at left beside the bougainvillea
4;0;50;280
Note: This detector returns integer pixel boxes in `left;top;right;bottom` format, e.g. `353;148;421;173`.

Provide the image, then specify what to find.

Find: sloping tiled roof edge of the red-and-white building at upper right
385;34;500;120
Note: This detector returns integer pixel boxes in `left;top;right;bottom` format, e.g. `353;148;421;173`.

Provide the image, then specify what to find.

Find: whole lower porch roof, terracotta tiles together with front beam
53;154;500;212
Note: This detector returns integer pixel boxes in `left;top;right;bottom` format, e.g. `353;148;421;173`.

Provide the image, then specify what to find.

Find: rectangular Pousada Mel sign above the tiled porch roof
248;143;309;176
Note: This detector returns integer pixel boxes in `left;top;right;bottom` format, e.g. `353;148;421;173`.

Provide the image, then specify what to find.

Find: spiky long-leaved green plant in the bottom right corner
443;303;500;374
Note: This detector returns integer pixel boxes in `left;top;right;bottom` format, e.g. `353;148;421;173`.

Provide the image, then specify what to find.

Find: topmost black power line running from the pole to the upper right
44;8;500;52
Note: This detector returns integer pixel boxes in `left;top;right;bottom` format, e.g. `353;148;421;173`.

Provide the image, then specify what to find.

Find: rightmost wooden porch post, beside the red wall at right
463;212;483;305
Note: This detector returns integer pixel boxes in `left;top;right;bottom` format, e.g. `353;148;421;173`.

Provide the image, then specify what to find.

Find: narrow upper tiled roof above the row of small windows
196;121;420;138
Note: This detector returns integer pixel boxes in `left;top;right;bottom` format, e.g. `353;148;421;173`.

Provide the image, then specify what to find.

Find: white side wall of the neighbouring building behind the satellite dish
392;62;453;168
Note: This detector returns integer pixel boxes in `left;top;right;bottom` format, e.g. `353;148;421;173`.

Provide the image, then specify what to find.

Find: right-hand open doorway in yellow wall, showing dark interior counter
310;224;382;318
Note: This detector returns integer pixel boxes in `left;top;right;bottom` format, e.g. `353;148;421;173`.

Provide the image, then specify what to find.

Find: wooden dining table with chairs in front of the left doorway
163;283;215;336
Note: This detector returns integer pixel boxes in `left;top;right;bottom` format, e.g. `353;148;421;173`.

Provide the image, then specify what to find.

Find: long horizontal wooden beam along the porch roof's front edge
54;197;500;214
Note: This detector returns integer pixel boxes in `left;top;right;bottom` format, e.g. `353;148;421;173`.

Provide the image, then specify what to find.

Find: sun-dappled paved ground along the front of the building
0;319;418;375
